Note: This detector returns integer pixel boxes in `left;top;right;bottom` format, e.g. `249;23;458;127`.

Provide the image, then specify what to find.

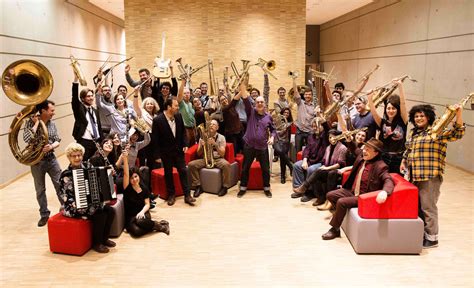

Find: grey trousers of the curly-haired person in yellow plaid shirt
413;176;443;241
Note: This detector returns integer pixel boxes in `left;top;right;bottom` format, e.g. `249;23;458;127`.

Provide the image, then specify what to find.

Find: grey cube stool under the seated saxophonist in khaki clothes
199;162;239;194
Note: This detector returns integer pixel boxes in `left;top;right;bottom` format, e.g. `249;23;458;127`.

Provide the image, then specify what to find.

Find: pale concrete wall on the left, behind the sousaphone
0;0;125;187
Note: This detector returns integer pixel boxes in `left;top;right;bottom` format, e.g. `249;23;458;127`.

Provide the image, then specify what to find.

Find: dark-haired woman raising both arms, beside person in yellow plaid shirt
368;80;408;173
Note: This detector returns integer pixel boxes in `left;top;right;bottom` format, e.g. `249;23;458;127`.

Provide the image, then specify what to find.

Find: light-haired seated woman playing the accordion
59;143;116;253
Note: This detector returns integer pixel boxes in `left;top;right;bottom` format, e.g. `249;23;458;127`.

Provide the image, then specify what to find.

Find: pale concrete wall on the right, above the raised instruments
320;0;474;172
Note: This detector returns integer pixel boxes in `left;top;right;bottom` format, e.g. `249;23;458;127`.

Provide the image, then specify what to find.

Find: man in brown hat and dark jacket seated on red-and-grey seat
322;138;394;240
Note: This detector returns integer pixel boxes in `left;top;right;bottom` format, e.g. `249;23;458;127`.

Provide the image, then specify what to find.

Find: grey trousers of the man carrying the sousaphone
31;157;64;217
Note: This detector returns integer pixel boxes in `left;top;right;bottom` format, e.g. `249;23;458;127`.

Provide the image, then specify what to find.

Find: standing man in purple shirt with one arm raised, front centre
237;84;276;198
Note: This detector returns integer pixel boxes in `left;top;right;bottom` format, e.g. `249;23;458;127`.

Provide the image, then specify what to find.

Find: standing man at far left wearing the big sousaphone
23;100;64;227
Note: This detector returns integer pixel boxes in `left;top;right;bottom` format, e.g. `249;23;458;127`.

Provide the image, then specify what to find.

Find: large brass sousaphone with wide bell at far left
2;59;53;165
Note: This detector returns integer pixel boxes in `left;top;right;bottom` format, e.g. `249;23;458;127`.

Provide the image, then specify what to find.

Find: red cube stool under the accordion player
48;213;92;256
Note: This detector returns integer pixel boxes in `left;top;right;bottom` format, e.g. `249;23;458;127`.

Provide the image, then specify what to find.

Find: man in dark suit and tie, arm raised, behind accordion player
71;74;102;161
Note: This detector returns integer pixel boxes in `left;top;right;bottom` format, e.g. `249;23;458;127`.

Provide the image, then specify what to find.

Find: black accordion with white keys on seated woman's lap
72;167;117;209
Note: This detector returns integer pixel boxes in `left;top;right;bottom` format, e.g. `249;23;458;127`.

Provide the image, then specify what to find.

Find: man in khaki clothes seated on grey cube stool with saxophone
188;120;230;197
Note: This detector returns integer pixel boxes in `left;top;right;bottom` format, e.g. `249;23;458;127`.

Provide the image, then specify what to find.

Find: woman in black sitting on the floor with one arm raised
122;151;170;237
